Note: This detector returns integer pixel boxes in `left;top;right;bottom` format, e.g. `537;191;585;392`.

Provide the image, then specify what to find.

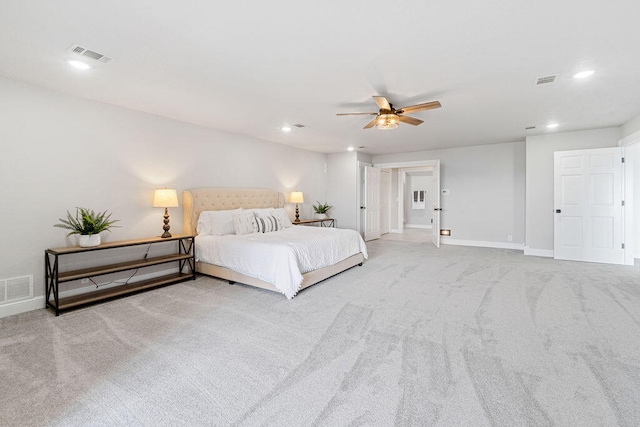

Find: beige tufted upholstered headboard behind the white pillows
182;188;284;234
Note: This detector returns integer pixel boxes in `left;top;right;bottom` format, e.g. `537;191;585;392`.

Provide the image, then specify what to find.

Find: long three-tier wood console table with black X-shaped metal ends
44;235;196;316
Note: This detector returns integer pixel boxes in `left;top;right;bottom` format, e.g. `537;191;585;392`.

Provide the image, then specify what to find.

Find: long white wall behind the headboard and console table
0;78;328;316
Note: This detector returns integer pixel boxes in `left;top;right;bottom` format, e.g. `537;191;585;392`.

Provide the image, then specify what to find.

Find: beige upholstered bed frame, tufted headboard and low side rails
182;188;364;292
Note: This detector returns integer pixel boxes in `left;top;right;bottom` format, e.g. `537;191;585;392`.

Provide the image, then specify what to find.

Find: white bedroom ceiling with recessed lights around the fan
0;0;640;154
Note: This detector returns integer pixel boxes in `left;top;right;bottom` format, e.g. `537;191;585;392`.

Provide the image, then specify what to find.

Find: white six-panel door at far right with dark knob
553;147;624;264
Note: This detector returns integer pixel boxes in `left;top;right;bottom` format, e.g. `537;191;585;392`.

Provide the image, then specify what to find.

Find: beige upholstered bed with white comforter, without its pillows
182;188;367;299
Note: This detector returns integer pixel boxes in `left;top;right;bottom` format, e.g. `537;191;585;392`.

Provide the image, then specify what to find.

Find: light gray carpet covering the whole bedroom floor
0;241;640;426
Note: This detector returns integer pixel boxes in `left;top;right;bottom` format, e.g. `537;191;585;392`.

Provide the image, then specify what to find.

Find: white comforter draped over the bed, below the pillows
196;226;368;299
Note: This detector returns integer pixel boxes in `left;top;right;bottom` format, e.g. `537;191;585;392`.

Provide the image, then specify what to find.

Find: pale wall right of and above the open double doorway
373;141;525;247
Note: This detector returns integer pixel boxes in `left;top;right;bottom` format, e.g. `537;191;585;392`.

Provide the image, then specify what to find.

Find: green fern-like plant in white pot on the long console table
54;208;119;248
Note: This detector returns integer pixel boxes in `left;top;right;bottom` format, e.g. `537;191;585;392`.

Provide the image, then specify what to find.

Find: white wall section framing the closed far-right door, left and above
525;128;620;256
